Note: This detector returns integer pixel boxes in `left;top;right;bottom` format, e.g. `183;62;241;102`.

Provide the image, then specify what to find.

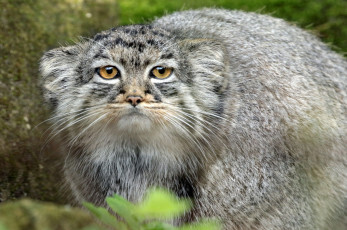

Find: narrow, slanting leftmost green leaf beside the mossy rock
83;202;127;230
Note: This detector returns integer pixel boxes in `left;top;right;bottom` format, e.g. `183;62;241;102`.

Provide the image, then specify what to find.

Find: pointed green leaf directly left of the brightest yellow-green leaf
106;195;141;230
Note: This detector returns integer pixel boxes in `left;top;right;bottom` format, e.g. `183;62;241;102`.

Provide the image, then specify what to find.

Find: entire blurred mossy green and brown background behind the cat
0;0;347;203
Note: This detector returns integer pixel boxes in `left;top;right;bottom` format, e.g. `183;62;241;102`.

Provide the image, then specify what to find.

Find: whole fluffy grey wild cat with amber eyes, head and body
41;9;347;229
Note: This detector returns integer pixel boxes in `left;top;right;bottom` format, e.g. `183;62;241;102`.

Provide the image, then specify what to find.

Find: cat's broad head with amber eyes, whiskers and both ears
41;25;227;145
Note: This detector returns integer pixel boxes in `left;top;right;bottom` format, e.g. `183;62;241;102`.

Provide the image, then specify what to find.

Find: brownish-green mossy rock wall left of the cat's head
0;0;118;202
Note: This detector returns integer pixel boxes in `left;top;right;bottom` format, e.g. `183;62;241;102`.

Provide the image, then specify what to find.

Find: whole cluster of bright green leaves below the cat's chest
84;189;220;230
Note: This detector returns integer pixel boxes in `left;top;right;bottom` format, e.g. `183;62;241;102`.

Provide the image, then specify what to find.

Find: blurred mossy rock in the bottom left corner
0;199;96;230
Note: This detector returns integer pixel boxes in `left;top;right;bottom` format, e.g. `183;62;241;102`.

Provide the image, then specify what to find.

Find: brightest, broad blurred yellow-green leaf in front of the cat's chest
135;189;190;219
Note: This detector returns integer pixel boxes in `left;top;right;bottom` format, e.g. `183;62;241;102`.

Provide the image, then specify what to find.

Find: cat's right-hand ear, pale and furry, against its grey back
179;38;229;93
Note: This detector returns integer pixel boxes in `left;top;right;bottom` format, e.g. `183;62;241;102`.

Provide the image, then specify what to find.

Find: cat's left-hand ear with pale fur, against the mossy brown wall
40;45;83;107
